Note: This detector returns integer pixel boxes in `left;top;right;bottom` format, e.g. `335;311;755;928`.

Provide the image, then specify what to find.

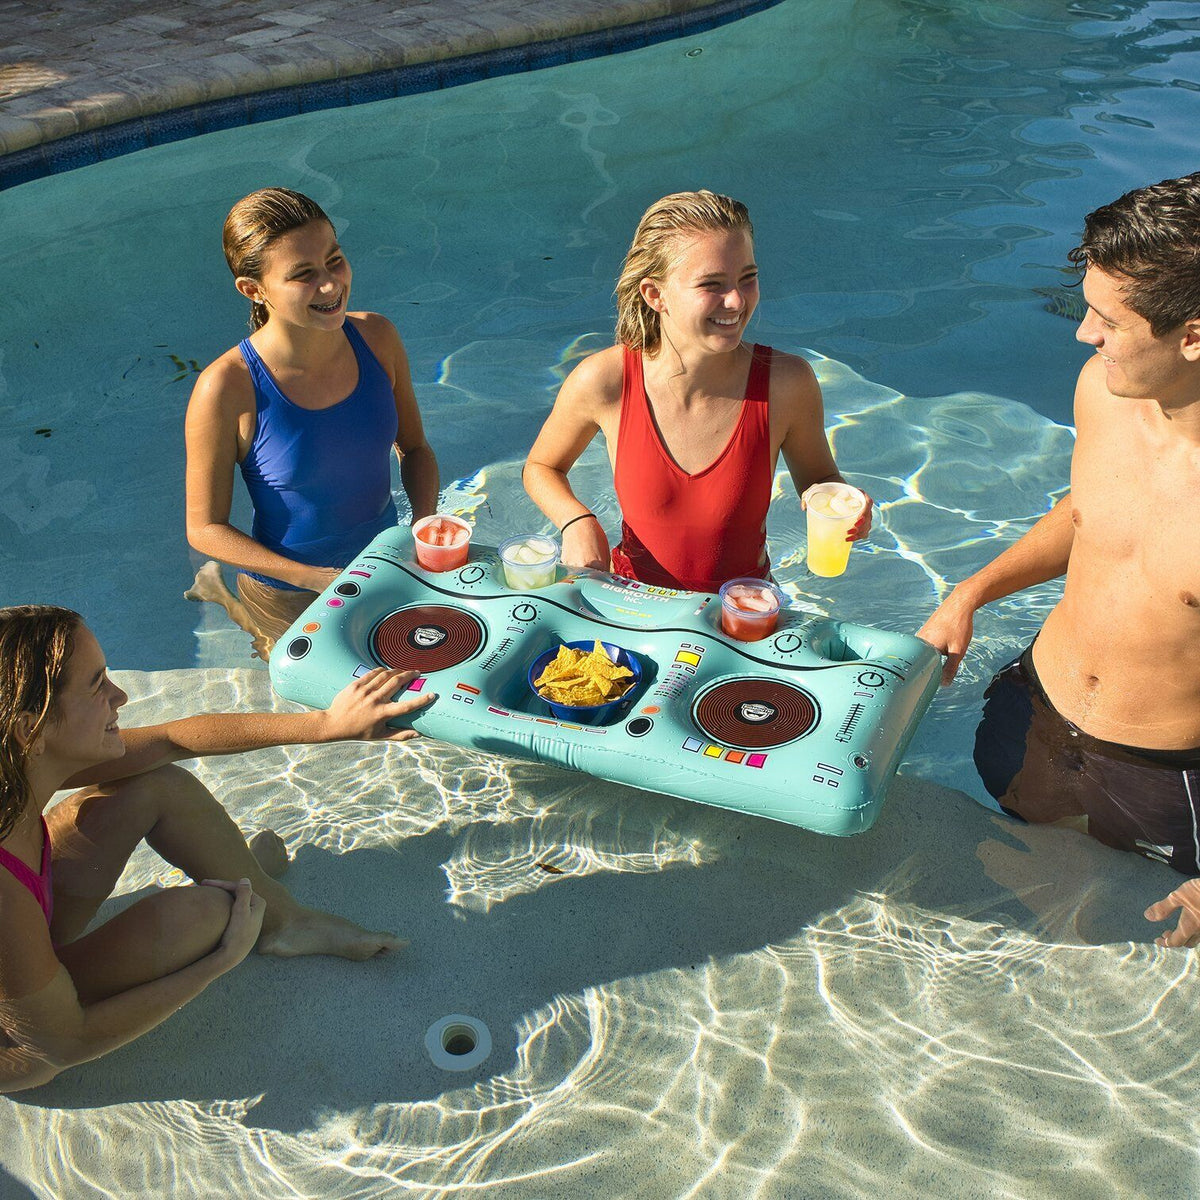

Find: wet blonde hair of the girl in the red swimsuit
617;190;754;358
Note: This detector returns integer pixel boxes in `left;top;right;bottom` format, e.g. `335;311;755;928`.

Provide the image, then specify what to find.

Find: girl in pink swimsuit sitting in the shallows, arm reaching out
0;605;428;1092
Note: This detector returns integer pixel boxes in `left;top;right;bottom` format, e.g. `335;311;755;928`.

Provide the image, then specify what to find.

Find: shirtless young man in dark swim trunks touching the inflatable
919;173;1200;946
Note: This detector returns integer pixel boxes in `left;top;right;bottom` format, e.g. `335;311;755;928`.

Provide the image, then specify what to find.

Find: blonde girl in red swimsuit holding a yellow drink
524;191;871;592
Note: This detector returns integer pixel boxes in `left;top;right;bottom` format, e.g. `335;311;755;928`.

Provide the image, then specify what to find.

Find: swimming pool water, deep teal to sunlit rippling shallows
0;0;1200;1196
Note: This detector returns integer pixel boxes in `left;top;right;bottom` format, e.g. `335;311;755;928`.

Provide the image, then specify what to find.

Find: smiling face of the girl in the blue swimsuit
236;221;350;330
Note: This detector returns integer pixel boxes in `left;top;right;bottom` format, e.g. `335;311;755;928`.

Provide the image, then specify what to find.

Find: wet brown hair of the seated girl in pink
0;604;83;838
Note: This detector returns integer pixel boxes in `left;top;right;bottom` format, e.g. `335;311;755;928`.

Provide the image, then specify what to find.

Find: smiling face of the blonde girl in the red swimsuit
642;229;758;353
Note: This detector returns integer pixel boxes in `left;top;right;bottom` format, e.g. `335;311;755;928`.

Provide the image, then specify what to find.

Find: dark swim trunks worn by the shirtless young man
974;646;1200;875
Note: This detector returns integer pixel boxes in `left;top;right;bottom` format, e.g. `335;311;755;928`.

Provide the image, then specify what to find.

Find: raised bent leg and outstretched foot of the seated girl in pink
47;767;407;959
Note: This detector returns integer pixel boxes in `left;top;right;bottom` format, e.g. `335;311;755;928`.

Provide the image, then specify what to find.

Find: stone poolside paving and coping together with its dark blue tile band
0;0;780;191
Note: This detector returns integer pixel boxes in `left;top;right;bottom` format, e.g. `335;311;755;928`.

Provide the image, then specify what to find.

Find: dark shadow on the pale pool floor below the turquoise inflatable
14;764;1177;1132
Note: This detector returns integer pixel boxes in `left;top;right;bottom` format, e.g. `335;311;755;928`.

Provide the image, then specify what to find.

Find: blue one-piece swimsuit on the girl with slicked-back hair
238;322;398;592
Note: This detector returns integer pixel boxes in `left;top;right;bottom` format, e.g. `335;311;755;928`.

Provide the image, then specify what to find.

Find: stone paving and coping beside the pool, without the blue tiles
0;0;719;155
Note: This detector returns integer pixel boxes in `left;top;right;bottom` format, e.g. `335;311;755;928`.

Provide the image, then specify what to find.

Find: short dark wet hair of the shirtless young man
1067;172;1200;337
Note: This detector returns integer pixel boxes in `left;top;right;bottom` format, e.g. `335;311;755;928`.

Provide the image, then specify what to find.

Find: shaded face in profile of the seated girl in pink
38;625;130;778
